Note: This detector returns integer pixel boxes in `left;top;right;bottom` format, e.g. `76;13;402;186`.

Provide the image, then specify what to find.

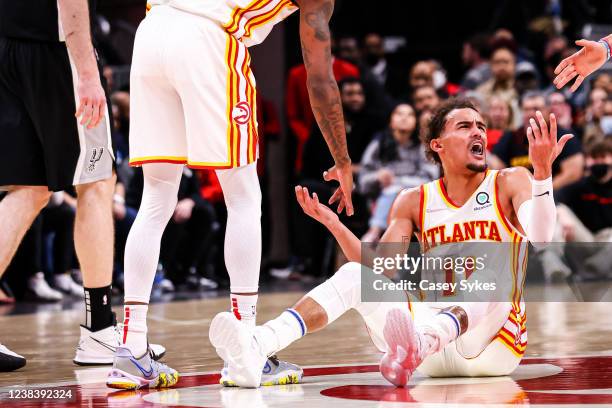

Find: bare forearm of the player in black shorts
59;0;99;78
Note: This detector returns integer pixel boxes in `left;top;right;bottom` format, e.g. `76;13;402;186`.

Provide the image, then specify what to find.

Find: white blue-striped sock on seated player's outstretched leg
255;309;307;356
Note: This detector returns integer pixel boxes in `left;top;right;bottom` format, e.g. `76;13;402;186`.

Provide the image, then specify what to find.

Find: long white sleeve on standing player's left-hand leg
124;163;183;303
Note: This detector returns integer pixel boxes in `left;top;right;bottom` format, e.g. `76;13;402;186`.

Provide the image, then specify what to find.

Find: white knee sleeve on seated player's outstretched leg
306;262;361;324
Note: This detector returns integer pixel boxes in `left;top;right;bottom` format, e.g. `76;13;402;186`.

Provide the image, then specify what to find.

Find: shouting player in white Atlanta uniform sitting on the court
210;99;572;387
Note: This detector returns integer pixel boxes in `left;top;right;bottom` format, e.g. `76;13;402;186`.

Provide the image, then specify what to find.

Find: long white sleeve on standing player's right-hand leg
217;163;261;293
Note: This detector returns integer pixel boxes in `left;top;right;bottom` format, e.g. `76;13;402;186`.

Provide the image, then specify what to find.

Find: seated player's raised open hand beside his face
527;111;574;180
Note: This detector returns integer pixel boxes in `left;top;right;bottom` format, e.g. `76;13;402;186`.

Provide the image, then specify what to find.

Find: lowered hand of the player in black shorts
75;73;106;129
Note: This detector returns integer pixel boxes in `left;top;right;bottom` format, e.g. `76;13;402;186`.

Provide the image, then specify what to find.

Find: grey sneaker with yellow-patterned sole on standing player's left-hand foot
106;347;179;390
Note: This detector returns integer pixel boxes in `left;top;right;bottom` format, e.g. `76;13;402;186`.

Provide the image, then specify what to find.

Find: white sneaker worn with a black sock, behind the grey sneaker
72;324;166;366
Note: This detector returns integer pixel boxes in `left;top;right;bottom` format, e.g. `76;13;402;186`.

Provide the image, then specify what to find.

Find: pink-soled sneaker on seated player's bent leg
380;309;424;387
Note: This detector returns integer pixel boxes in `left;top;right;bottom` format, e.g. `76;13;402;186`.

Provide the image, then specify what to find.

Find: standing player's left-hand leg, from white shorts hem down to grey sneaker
106;163;183;389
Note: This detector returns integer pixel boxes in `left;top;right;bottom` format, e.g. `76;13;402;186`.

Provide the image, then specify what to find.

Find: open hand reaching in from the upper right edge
553;40;607;92
